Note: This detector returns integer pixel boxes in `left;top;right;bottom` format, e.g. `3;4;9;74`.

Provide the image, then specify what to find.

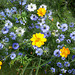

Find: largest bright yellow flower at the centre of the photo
30;33;47;47
